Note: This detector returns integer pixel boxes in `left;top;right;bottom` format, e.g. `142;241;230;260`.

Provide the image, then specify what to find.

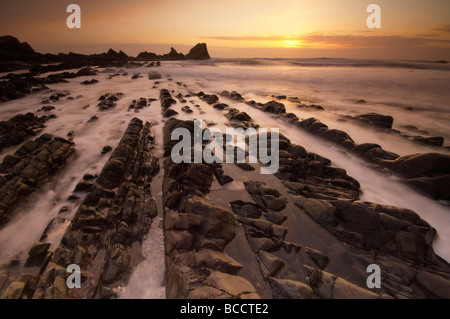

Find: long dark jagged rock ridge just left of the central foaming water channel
3;118;159;299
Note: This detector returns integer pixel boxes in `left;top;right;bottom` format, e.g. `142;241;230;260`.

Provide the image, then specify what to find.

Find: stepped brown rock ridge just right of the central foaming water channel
163;119;259;298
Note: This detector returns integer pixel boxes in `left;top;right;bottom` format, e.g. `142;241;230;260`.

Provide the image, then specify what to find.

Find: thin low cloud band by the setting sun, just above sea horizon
204;33;450;48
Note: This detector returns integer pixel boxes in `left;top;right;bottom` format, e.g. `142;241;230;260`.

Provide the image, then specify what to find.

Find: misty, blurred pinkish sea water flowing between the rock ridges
0;59;450;276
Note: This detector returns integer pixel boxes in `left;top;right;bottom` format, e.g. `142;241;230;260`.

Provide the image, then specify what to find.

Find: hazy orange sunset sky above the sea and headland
0;0;450;60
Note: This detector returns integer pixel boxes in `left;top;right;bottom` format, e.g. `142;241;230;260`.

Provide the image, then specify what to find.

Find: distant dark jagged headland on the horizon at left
0;36;211;101
